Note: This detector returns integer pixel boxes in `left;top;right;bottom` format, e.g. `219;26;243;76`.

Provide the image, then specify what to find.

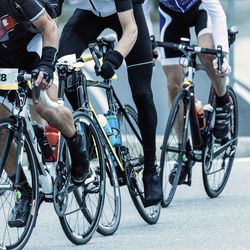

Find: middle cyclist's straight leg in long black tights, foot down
109;4;162;206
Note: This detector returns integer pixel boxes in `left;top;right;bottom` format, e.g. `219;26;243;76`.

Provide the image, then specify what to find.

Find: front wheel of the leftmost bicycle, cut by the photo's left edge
0;118;39;249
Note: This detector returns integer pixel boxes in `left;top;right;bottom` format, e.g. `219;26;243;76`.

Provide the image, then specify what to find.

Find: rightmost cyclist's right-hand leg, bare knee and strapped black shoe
195;6;231;139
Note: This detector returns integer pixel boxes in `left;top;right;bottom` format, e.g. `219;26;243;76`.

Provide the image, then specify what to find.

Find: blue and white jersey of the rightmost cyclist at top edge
159;0;200;13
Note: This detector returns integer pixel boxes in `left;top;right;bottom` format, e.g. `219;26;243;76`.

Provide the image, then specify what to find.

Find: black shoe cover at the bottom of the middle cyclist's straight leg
143;166;163;207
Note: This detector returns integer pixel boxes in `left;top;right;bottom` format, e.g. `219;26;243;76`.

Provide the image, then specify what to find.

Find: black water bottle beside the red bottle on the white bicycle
32;122;53;159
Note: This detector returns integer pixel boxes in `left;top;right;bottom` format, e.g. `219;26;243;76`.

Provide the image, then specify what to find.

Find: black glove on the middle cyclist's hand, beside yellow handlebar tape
100;50;123;79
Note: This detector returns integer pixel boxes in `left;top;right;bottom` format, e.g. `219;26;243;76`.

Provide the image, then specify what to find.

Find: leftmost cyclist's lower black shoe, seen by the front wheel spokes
8;182;32;227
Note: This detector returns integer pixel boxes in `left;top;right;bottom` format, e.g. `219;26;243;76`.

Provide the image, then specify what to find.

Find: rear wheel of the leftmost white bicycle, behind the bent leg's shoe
59;112;105;245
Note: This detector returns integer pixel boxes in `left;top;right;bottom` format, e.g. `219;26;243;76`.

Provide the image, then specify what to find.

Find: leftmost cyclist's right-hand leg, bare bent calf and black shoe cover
27;34;89;185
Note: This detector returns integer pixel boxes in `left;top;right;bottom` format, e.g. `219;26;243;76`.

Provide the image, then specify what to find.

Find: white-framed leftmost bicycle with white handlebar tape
0;69;105;249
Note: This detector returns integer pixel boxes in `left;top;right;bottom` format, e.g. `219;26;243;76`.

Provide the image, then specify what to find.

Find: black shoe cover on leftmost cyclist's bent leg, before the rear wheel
66;131;91;186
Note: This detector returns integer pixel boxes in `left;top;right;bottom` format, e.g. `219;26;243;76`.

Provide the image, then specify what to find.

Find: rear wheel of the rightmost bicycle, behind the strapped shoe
202;87;238;198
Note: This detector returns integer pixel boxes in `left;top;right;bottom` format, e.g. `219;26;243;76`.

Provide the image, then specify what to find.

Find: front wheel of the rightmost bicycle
160;91;187;207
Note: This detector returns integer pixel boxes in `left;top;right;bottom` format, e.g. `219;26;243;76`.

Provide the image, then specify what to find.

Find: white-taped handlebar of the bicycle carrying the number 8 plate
17;70;58;109
